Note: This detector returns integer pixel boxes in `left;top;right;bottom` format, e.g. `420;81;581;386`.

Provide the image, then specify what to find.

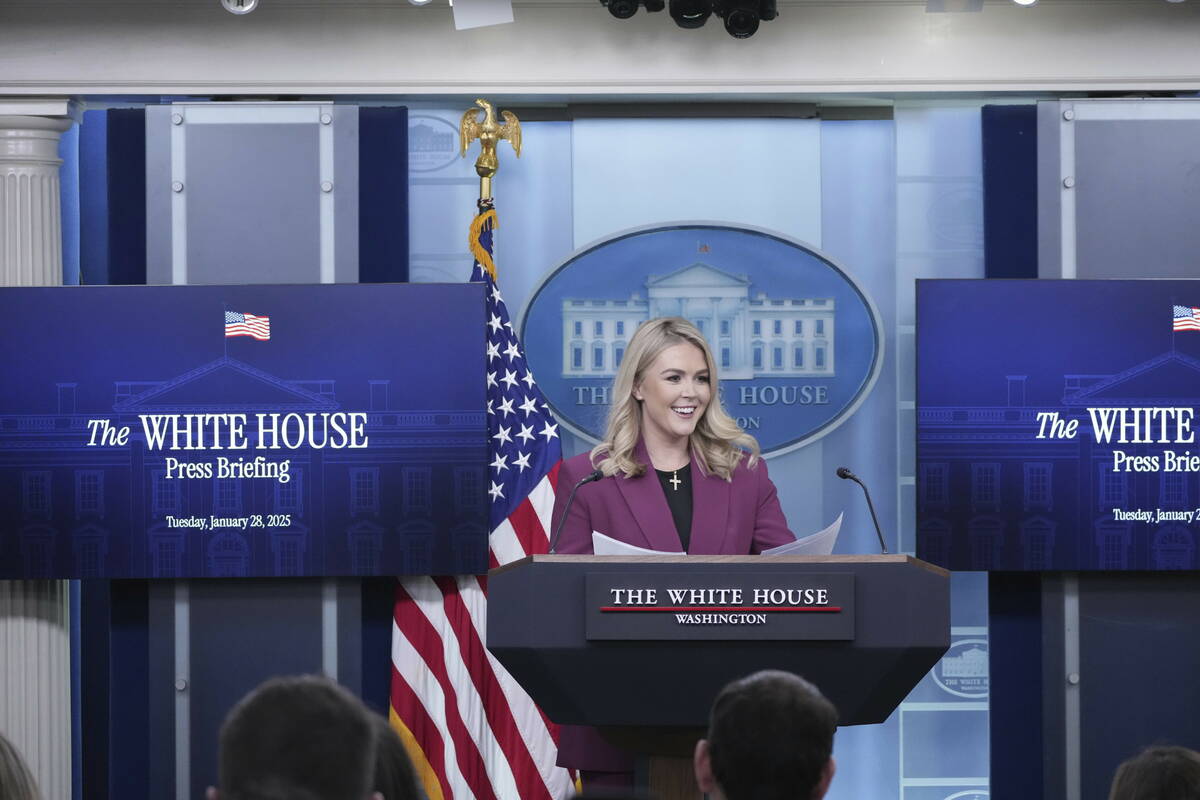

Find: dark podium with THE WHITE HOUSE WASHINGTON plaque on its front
487;555;950;800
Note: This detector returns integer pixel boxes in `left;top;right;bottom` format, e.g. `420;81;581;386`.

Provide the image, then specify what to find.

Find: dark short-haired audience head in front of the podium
695;670;838;800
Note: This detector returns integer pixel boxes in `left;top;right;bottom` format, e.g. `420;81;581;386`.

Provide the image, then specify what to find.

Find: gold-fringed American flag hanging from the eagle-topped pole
391;204;571;800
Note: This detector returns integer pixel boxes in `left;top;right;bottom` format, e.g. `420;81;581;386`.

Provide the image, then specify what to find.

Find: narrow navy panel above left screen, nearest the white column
106;108;146;285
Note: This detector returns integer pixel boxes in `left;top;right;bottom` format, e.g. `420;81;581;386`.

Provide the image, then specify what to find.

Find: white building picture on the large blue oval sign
563;261;835;380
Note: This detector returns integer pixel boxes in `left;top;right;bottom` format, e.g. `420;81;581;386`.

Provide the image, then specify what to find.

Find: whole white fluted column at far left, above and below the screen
0;106;71;800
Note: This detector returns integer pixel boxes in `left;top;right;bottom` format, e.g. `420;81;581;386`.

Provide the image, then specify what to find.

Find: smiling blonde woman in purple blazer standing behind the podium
552;317;796;787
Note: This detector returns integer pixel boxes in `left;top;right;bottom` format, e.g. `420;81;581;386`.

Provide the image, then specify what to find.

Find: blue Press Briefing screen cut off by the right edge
916;281;1200;570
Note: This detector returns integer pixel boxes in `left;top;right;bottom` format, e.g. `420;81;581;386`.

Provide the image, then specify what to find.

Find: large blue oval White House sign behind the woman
521;223;883;455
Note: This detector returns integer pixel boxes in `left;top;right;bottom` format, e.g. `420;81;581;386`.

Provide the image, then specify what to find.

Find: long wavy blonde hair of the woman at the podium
592;317;758;481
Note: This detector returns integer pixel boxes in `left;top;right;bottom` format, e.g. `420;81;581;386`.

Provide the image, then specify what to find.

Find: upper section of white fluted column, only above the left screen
0;115;71;287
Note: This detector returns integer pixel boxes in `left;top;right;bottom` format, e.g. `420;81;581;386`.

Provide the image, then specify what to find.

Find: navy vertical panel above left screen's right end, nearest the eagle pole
359;108;408;283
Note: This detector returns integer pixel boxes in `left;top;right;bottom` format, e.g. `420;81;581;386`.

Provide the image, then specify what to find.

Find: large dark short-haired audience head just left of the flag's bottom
209;675;376;800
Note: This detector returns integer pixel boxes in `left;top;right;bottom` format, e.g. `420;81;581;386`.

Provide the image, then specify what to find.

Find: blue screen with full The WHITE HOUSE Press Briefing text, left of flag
0;284;487;578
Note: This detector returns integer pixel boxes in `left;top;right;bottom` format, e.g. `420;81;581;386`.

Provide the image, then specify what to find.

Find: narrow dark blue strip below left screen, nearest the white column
109;581;151;800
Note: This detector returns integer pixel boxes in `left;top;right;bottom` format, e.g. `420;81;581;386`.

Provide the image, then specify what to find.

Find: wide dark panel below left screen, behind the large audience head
188;579;322;798
